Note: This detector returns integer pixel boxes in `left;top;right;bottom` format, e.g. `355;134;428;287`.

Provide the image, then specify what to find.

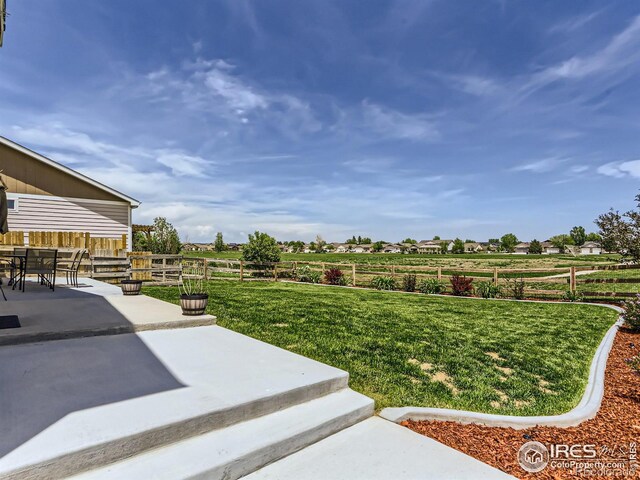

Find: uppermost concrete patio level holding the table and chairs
0;278;215;346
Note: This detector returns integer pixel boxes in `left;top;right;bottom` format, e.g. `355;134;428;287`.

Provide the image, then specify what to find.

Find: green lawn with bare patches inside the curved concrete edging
144;280;617;415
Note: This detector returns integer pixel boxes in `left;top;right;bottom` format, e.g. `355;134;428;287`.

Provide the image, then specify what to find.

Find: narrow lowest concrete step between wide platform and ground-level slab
73;389;373;480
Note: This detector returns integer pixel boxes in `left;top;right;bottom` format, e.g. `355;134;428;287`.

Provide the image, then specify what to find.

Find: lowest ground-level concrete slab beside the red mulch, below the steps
244;417;514;480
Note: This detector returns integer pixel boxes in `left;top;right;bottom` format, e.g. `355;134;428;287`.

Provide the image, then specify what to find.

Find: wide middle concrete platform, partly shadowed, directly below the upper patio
0;326;348;480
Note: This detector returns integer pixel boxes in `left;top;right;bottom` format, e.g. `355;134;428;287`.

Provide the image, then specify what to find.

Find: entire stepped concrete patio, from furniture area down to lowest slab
0;279;508;480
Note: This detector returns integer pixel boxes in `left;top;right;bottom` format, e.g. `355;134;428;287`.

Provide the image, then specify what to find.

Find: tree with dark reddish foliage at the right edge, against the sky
595;195;640;263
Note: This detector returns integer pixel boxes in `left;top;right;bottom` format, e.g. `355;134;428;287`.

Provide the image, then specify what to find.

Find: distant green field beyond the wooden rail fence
183;252;620;270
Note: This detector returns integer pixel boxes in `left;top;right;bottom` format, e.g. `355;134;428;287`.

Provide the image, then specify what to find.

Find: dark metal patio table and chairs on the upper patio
0;248;88;300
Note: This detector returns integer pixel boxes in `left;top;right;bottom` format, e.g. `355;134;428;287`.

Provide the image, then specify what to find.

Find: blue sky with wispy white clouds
0;0;640;241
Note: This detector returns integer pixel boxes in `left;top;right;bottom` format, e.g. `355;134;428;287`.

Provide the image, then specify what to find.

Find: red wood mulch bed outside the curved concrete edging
402;328;640;479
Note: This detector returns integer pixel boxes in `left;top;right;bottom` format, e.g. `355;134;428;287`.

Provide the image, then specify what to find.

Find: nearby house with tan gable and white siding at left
0;137;140;250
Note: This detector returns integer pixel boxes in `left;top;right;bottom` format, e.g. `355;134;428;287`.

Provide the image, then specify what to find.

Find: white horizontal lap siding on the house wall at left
9;194;130;239
